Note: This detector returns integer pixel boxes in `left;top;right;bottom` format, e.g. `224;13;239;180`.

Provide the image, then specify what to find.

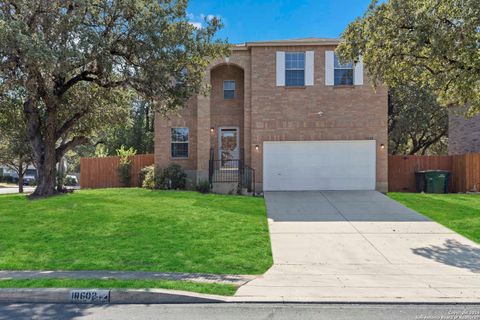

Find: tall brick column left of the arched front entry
197;68;210;182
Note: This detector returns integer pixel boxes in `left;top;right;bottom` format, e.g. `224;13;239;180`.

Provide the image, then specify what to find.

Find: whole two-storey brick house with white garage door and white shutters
155;38;388;192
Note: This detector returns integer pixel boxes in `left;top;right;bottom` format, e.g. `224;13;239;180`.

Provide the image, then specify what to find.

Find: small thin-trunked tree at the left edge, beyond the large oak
0;99;33;193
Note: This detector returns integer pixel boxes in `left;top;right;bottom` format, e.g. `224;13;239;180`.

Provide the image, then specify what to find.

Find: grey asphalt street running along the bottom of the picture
0;304;480;320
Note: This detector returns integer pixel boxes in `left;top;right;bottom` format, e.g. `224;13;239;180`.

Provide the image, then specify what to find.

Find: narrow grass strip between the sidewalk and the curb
0;279;237;296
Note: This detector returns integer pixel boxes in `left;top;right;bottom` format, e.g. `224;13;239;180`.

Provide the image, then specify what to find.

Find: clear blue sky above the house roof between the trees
188;0;371;44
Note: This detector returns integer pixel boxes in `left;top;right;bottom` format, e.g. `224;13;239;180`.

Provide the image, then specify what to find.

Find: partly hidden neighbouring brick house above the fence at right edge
448;112;480;154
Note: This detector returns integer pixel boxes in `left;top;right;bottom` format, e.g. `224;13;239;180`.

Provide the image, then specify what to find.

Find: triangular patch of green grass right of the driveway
388;193;480;243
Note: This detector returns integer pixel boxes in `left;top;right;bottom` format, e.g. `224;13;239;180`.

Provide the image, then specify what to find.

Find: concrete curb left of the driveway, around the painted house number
0;288;228;304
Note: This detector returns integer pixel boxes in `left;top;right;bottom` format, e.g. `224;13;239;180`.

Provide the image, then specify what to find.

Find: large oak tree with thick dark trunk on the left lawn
0;0;227;196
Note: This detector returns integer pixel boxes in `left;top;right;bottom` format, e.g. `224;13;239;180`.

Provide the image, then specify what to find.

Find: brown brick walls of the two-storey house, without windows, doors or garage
155;38;388;191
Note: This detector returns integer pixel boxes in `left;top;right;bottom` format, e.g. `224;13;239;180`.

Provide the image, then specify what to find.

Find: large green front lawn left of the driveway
0;189;272;274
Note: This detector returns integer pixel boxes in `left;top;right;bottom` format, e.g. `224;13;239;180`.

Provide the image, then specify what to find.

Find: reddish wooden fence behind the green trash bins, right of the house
388;153;480;192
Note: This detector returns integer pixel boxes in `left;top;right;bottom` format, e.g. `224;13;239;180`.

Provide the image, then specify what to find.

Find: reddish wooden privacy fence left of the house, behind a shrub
80;154;154;188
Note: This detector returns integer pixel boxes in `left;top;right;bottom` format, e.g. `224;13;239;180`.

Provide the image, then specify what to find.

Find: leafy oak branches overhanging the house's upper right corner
338;0;480;114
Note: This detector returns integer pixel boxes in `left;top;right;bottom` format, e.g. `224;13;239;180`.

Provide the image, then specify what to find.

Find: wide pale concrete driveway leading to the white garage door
236;191;480;302
